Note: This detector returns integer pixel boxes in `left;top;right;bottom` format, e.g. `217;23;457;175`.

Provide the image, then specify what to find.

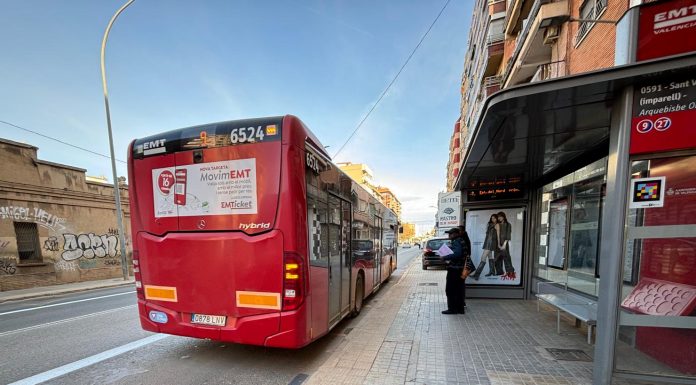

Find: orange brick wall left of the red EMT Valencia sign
566;0;629;74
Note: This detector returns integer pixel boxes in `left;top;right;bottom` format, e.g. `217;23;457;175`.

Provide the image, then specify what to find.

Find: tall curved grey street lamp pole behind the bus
101;0;135;281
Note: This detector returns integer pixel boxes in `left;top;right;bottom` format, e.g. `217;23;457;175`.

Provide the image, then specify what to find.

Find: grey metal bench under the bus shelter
536;282;597;344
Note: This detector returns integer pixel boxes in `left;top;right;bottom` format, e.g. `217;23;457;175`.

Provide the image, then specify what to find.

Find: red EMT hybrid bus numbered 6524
128;115;398;348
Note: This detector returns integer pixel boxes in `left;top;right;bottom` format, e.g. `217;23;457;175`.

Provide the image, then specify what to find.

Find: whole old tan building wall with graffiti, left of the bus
0;139;131;291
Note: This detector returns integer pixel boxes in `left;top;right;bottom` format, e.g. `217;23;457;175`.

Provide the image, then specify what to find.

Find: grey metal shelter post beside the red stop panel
592;86;633;385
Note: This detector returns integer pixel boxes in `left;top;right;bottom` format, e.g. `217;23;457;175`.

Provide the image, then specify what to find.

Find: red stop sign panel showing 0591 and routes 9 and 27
630;73;696;154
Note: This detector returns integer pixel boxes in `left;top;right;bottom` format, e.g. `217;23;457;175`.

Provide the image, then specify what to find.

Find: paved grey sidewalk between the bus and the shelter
306;260;593;385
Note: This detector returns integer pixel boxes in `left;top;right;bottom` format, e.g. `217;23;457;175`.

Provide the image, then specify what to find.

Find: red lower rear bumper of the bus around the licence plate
138;300;310;348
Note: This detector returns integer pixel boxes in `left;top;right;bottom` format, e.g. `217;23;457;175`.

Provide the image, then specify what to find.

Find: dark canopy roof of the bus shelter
455;54;696;191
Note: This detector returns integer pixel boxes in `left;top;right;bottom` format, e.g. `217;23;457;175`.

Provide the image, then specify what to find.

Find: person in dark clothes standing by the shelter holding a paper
440;227;471;314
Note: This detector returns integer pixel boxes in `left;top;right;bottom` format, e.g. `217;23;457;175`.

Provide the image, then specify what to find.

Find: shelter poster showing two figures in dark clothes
466;207;524;286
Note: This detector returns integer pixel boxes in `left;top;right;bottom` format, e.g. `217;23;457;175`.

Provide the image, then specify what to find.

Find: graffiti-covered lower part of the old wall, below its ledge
0;200;129;290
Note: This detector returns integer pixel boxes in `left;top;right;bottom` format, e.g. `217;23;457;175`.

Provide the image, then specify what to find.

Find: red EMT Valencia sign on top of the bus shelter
636;0;696;61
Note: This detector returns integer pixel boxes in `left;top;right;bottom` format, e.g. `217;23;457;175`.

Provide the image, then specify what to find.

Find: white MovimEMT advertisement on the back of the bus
152;158;257;218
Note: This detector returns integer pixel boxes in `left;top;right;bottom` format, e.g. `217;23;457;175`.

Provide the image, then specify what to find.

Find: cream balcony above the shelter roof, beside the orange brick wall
503;0;570;88
